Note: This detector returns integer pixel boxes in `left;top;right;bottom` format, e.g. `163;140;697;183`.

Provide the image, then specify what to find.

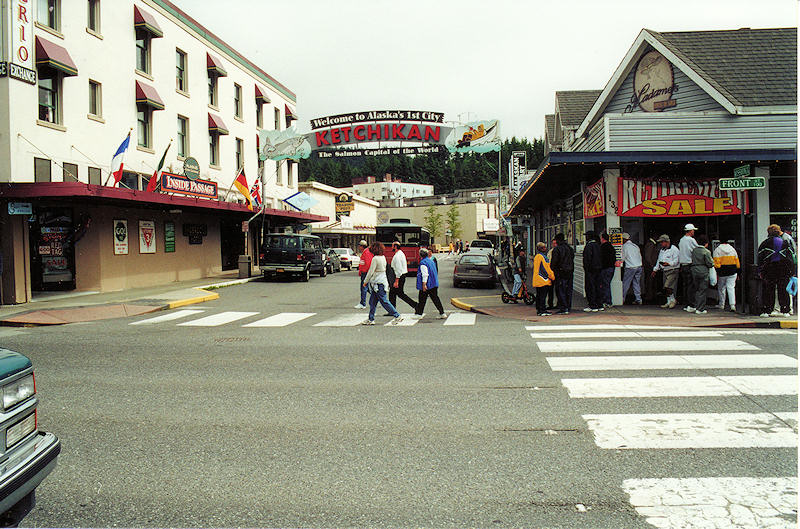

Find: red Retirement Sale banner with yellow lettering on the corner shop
617;178;748;217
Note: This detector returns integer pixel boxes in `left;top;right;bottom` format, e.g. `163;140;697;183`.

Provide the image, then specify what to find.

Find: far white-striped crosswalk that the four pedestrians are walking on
130;309;477;328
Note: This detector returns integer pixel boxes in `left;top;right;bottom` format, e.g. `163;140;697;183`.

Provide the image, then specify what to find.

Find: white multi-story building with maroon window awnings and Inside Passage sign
0;0;321;303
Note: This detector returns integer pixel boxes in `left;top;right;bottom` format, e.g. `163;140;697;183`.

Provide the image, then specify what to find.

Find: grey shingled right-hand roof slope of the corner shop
647;28;797;107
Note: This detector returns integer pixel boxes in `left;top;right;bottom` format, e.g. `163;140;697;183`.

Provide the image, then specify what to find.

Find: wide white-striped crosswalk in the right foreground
526;325;798;528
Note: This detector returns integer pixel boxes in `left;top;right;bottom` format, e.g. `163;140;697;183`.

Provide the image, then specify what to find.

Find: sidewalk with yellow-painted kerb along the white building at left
0;272;260;327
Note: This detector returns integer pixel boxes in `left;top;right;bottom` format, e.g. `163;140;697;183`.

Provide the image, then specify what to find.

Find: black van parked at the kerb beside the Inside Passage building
259;233;328;281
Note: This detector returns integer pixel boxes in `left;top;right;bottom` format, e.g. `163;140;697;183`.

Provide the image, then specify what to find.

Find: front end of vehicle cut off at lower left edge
0;348;61;527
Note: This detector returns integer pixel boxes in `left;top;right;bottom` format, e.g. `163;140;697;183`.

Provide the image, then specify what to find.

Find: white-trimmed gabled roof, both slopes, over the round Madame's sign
577;28;797;136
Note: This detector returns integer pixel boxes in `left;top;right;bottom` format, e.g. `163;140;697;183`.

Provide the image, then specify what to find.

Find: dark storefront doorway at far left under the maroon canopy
30;208;75;291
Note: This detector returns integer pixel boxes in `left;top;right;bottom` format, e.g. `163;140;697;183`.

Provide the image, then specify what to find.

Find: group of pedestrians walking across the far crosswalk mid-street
355;240;447;325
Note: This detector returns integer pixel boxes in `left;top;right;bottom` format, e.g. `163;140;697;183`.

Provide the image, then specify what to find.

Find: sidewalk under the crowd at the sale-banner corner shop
450;294;797;329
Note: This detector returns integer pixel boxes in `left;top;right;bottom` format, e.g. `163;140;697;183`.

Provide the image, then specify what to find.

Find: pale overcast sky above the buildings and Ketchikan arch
174;0;798;139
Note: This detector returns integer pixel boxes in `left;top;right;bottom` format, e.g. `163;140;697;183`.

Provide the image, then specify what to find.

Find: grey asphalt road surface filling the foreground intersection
0;255;797;528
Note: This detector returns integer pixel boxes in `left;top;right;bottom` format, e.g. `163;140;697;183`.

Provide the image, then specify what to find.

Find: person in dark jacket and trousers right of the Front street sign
758;224;797;318
